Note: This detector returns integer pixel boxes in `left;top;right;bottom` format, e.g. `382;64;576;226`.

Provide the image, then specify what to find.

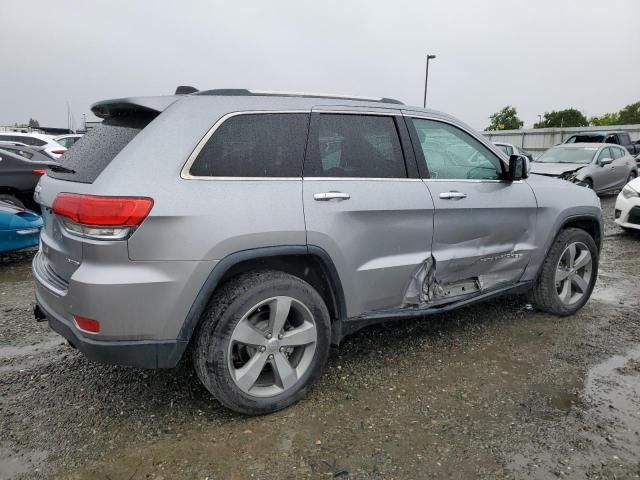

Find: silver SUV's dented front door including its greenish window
406;112;537;294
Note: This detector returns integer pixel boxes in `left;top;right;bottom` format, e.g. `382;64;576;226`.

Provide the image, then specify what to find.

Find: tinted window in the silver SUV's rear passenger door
304;113;407;178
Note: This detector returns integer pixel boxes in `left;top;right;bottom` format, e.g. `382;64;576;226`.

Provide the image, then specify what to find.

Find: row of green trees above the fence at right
485;102;640;131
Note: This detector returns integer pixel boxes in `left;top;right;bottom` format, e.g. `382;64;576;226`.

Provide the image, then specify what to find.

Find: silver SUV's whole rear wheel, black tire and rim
193;271;331;415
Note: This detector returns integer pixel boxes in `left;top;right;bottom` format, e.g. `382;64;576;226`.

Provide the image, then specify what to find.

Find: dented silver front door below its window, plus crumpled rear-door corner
404;180;537;307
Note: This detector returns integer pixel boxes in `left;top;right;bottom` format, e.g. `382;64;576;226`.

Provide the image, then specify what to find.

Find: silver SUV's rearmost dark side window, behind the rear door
189;113;309;177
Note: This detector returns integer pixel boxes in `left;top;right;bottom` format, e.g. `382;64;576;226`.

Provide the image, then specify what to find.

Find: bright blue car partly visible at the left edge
0;201;42;253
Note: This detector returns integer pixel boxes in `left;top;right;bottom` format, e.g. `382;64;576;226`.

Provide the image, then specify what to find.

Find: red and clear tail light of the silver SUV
52;193;153;240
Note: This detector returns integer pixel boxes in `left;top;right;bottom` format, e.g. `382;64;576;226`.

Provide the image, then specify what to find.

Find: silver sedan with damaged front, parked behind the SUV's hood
531;143;638;193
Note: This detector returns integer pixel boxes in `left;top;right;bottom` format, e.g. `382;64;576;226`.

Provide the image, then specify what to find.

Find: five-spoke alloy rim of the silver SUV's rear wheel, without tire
228;296;318;397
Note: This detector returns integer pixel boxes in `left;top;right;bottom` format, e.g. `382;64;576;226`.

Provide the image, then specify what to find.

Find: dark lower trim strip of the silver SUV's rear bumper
36;293;186;368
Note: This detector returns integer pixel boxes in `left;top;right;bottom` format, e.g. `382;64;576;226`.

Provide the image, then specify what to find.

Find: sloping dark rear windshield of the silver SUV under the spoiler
47;113;156;183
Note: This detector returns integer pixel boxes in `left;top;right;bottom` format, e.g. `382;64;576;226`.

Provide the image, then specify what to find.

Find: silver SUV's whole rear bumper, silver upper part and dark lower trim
33;251;212;368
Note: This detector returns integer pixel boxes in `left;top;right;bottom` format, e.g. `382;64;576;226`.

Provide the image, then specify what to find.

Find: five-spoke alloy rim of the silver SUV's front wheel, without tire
555;242;593;305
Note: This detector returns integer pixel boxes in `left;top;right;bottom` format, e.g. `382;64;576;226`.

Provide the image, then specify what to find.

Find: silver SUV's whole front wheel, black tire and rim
529;228;598;316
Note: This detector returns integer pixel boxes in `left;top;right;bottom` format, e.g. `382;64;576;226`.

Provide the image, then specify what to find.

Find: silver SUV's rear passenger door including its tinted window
303;108;433;316
